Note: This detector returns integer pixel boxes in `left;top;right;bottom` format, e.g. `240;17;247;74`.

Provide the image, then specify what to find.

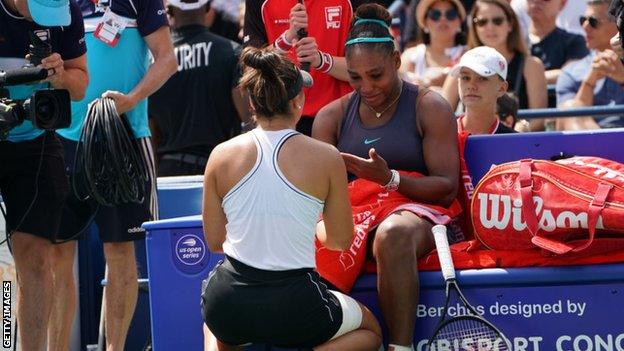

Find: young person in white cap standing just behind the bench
451;46;515;134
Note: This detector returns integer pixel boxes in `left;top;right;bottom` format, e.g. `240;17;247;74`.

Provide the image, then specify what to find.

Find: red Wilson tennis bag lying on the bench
471;157;624;254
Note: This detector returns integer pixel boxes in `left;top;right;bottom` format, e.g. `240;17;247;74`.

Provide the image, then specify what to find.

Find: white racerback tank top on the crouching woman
222;129;324;270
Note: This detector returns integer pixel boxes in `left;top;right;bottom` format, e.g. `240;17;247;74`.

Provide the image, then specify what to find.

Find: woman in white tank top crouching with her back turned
202;47;381;350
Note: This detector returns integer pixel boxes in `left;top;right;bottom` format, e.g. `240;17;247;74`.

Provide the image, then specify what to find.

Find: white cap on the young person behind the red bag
450;46;507;79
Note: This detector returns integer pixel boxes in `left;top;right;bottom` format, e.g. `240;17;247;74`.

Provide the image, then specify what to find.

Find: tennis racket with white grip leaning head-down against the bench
427;225;512;351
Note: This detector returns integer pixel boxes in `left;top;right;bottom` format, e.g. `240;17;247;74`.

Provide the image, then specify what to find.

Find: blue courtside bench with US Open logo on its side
144;130;624;351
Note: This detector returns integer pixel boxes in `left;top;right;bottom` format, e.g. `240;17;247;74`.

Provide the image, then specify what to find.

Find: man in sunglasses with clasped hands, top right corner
557;0;624;130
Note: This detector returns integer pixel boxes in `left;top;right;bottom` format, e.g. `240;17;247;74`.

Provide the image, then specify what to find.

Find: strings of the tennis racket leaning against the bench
430;319;509;351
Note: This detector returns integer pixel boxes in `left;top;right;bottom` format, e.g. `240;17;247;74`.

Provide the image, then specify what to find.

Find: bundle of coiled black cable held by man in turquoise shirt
72;98;149;206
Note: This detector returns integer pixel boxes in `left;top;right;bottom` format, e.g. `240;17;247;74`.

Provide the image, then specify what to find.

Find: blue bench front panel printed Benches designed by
404;283;624;351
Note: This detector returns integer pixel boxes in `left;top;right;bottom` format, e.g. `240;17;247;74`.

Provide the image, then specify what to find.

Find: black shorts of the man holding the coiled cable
60;138;158;243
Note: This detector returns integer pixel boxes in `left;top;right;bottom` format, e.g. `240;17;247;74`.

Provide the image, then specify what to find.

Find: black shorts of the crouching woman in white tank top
201;257;343;348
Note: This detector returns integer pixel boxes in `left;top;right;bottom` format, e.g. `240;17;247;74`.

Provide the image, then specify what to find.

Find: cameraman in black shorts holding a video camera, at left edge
0;0;88;350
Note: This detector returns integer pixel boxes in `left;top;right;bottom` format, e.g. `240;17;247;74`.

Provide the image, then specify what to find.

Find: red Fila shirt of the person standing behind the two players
244;0;359;117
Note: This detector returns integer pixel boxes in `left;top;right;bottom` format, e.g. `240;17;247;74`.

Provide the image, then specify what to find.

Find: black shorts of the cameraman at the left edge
0;132;69;241
